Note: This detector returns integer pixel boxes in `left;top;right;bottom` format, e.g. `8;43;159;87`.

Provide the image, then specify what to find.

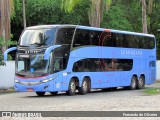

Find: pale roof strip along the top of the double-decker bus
26;24;155;37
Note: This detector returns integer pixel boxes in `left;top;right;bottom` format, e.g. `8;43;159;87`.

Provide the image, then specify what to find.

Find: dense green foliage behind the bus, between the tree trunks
12;0;160;59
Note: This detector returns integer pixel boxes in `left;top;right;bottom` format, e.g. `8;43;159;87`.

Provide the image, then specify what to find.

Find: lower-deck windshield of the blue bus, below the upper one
16;54;49;77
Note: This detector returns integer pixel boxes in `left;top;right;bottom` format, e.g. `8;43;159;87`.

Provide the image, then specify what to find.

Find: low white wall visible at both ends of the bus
0;60;160;88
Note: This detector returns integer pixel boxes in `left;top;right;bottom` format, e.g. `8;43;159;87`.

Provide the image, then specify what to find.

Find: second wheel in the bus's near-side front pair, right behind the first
79;78;89;95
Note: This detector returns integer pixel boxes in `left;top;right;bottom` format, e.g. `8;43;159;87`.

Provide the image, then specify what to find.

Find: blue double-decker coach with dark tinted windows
4;25;156;96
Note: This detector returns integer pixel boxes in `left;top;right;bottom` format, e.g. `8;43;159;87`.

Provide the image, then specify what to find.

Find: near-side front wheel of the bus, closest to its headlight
66;78;76;96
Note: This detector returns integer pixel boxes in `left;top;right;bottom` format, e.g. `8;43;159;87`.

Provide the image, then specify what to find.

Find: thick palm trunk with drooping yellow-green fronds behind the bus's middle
62;0;111;27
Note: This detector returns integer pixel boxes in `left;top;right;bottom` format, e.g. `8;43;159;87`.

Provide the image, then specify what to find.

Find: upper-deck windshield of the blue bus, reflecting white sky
20;28;56;46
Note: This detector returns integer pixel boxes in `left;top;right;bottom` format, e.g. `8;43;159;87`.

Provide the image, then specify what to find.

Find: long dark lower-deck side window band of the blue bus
73;58;133;72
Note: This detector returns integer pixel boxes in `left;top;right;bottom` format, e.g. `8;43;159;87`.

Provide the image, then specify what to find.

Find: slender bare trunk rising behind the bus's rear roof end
142;0;148;33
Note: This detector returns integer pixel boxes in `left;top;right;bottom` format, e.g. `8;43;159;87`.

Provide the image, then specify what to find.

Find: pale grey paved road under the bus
0;83;160;111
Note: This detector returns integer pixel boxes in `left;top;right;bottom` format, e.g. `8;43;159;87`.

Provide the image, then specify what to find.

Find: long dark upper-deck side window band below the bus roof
73;29;155;49
